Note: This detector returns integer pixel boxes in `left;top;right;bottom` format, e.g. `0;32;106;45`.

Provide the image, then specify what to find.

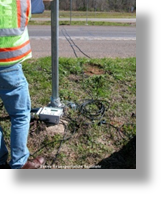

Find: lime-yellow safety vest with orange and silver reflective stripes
0;0;32;66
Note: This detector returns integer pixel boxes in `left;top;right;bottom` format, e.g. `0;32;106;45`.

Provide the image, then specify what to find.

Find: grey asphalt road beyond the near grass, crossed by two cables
28;26;136;58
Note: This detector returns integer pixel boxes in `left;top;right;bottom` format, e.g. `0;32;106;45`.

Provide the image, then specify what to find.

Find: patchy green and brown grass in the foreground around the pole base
0;57;136;169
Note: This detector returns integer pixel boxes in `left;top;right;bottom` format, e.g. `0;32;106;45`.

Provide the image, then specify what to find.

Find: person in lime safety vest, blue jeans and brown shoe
0;0;45;169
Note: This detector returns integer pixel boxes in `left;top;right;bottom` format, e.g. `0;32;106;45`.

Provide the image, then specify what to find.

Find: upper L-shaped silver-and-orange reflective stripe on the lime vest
0;0;31;36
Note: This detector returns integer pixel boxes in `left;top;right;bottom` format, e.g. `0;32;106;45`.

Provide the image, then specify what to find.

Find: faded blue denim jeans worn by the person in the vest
0;63;31;169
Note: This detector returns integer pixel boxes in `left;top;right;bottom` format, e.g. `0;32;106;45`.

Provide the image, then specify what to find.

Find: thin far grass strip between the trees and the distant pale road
32;10;136;18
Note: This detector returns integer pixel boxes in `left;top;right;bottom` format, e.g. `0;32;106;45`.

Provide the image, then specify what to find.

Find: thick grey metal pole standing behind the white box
51;0;62;107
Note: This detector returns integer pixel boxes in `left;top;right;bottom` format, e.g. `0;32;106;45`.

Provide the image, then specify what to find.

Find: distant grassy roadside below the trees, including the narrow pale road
30;10;136;26
